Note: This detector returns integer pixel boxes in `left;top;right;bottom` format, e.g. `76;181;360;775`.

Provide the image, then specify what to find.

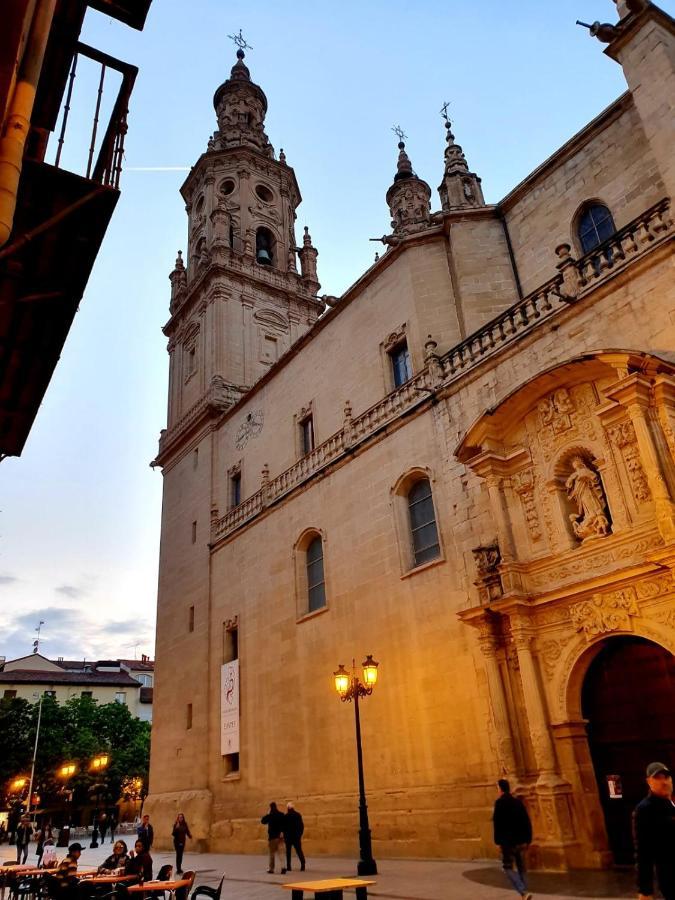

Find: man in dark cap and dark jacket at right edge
633;762;675;900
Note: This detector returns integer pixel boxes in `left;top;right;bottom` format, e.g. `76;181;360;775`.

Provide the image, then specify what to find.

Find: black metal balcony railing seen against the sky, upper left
54;43;138;190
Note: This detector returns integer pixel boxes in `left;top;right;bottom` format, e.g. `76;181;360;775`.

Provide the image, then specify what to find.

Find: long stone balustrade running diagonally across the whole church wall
211;200;675;544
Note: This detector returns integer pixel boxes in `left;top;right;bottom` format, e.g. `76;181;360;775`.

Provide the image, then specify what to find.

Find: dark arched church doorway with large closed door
581;637;675;865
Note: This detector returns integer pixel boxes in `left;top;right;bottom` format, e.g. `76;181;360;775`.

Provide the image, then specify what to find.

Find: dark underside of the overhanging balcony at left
0;160;119;456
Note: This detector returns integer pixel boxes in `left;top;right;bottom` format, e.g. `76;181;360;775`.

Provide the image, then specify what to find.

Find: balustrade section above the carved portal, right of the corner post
440;199;674;377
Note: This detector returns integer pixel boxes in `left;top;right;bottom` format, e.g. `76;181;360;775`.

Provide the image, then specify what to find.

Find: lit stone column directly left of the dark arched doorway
511;616;561;785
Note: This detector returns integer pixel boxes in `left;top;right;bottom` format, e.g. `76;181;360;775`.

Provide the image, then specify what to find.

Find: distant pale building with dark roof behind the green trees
0;653;154;722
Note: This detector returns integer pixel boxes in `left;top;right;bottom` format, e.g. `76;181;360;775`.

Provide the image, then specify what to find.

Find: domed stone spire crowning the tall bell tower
213;46;274;158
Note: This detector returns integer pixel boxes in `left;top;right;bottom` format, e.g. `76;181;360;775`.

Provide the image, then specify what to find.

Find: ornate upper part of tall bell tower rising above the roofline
160;35;324;446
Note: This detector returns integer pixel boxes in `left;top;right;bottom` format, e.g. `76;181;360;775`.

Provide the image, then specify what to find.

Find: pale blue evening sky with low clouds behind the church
0;0;675;658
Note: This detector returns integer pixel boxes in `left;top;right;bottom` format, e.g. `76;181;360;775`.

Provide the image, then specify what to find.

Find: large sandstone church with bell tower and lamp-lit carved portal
151;0;675;867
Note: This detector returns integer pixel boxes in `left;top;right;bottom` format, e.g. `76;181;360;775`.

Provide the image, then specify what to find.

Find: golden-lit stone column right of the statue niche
605;373;675;543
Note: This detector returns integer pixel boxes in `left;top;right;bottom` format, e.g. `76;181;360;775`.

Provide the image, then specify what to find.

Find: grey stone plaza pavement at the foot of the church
0;835;637;900
